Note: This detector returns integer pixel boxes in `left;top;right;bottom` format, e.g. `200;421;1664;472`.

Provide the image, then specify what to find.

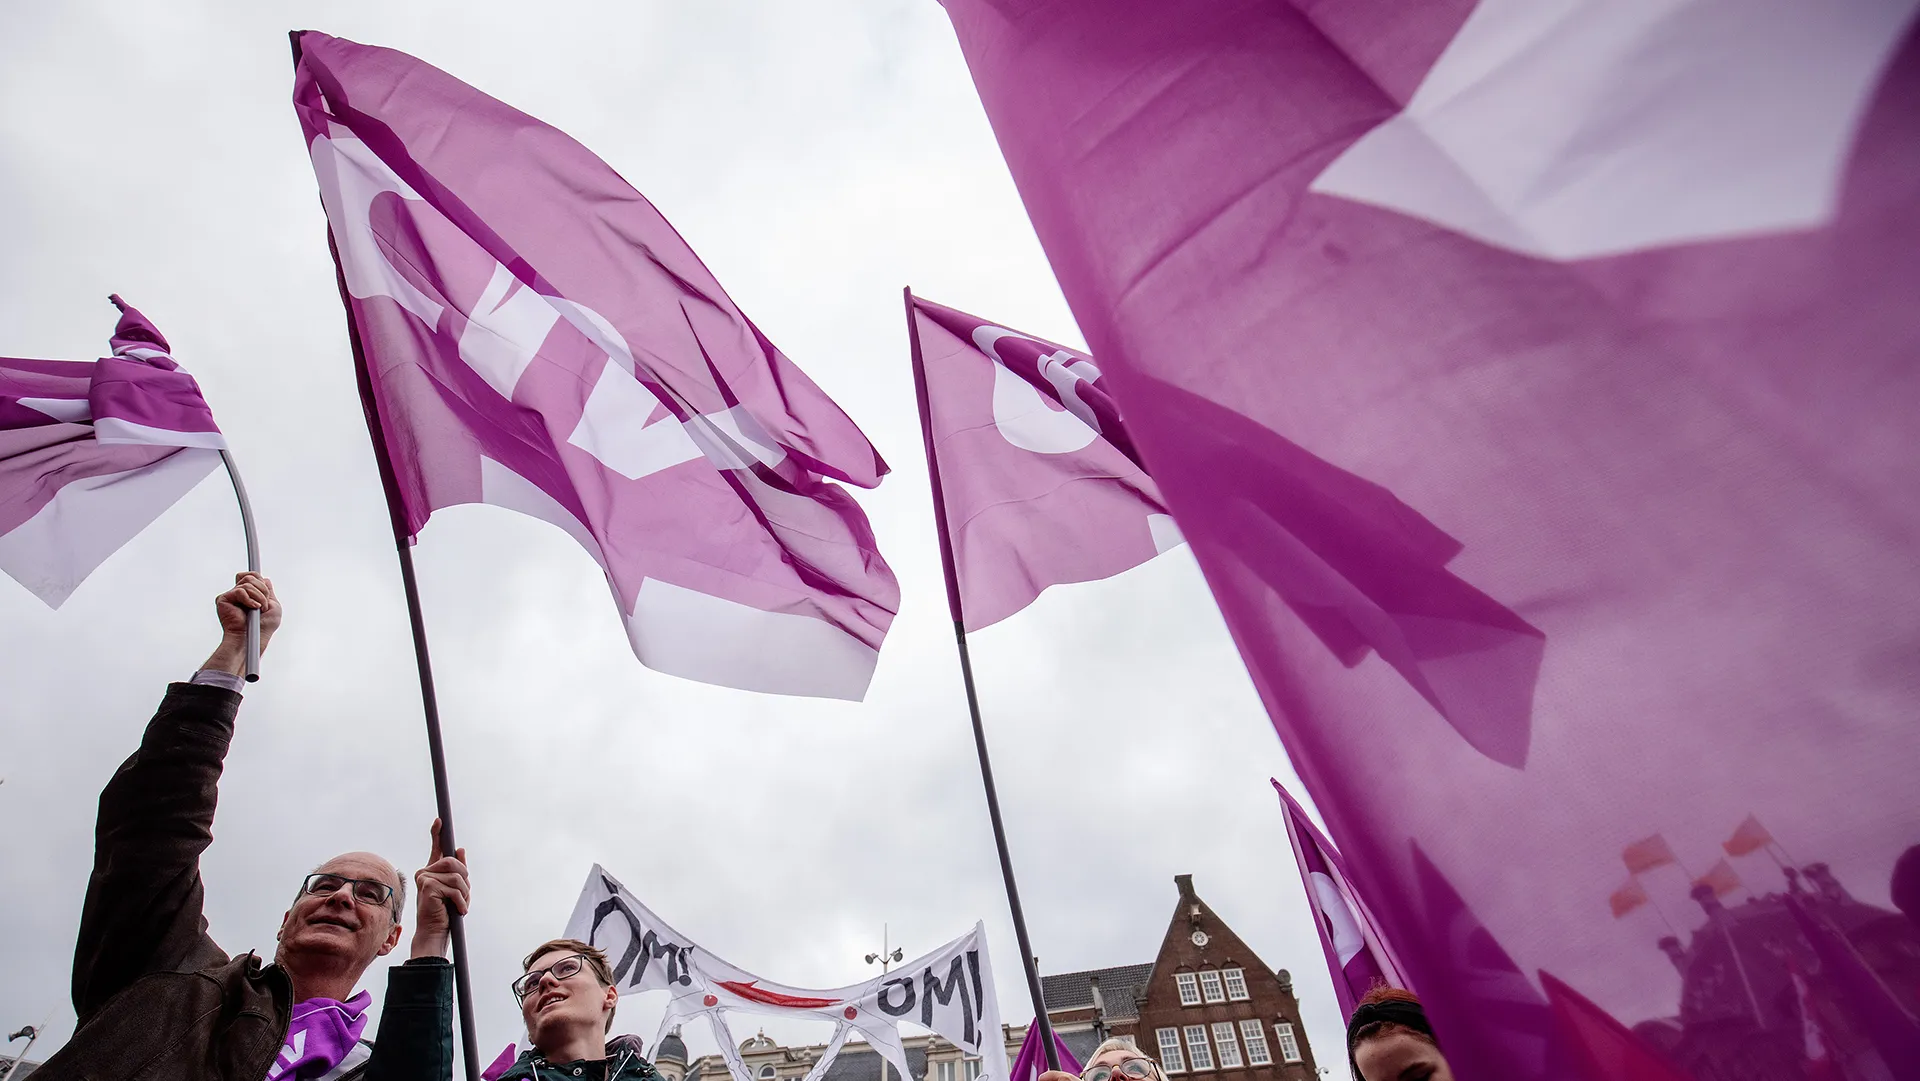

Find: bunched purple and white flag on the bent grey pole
0;296;227;609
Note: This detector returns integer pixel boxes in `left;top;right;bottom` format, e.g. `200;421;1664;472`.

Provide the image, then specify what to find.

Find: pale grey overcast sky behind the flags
0;0;1344;1073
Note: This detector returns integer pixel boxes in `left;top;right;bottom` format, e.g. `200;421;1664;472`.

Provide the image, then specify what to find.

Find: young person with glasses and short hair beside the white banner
488;939;660;1081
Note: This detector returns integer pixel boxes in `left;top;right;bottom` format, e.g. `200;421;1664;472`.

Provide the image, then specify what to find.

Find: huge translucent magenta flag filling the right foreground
945;0;1920;1081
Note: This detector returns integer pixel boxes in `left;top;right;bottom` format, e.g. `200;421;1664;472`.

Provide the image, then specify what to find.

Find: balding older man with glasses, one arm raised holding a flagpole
35;574;468;1081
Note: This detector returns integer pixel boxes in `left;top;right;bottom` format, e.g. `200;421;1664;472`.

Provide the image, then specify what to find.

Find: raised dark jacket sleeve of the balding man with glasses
73;684;240;1023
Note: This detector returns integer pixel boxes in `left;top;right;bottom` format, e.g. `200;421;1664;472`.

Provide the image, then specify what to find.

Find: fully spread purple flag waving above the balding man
294;31;899;699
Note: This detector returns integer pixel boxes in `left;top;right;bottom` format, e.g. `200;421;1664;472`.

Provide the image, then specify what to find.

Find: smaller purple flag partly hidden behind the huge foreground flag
910;298;1181;630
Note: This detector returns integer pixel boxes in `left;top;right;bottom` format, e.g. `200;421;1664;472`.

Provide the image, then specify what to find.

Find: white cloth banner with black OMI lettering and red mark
566;864;1008;1081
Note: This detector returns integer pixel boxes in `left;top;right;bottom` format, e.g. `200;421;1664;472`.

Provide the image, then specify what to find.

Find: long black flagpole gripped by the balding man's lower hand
288;31;480;1081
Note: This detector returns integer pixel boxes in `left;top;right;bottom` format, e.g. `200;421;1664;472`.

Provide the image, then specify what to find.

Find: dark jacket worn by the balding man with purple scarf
35;684;453;1081
